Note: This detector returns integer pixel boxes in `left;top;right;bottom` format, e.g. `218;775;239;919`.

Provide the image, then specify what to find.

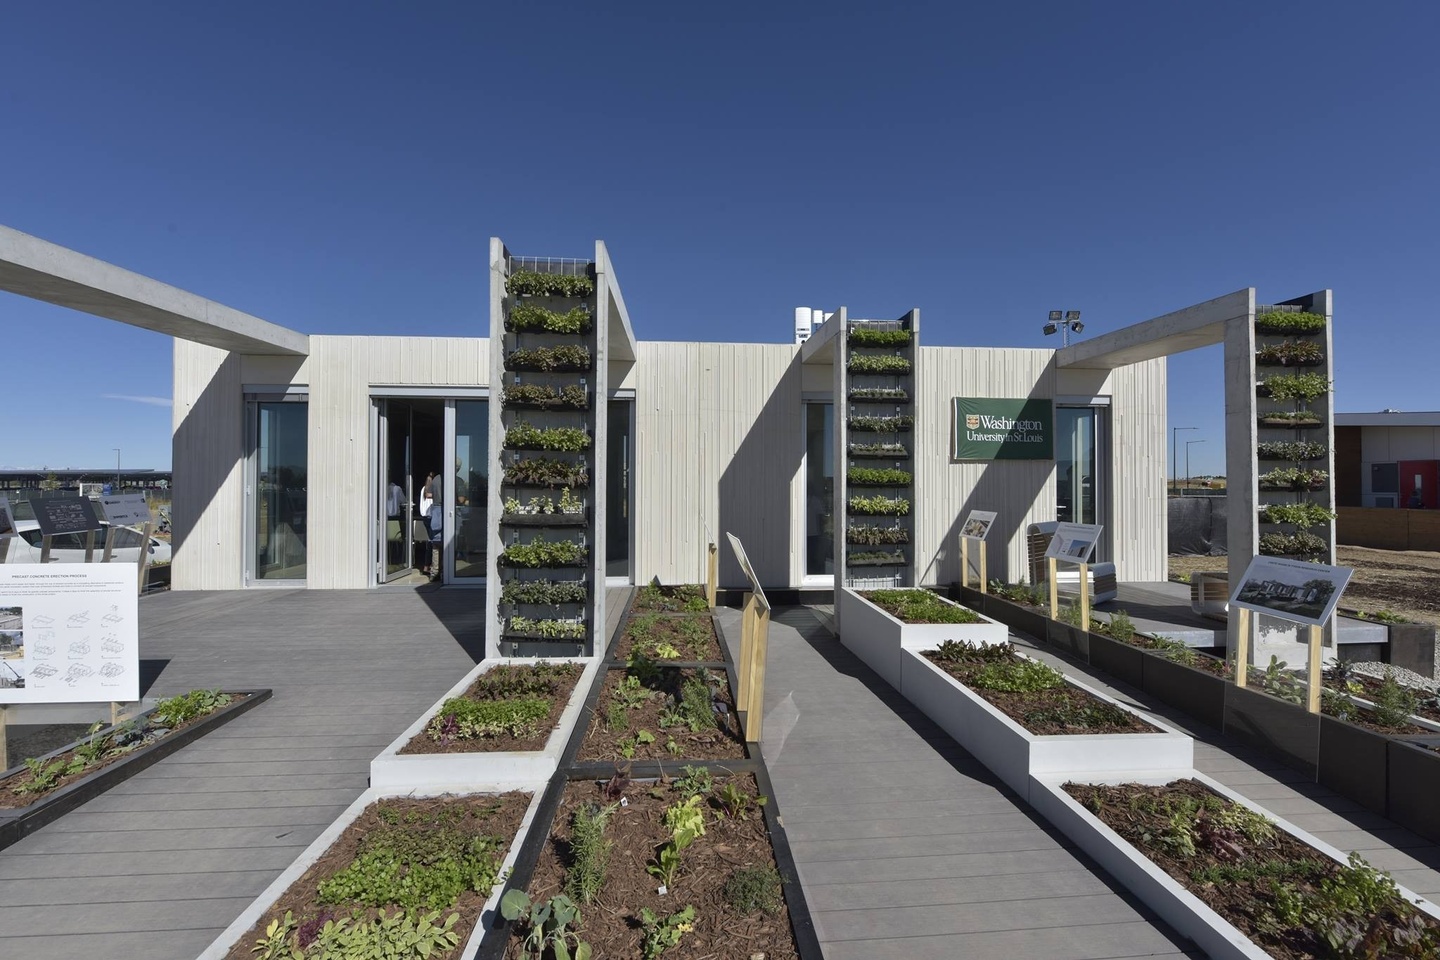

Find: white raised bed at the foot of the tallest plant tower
370;658;599;790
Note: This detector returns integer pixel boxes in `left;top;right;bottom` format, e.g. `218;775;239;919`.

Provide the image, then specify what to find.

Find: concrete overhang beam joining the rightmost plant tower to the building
1056;288;1256;370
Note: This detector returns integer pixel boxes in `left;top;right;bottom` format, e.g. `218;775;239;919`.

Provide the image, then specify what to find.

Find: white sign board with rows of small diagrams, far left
0;563;140;704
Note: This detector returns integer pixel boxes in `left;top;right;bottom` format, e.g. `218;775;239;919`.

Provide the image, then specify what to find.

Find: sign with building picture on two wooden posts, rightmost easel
1230;557;1355;714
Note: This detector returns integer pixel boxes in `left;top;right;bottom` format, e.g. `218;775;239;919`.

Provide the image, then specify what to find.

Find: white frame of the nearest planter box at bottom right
1030;770;1440;960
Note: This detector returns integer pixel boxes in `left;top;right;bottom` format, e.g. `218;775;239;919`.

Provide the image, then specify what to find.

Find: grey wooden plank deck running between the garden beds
0;587;1440;960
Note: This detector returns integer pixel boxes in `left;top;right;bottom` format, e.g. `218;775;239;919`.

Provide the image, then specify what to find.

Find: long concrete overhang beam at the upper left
0;226;310;357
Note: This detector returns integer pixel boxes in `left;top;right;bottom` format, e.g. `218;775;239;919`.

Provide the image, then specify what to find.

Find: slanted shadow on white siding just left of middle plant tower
714;353;805;587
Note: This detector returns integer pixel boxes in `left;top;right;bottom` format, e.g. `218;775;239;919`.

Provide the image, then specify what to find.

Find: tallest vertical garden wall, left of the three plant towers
485;240;605;656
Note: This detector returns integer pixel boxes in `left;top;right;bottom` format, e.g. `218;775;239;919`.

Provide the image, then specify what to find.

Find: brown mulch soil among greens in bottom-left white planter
225;793;530;960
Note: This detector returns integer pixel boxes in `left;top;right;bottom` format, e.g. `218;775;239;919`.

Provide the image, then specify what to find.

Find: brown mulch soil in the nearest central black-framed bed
505;770;799;960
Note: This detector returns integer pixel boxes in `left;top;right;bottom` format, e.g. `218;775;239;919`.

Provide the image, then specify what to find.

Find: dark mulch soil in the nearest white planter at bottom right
1064;780;1440;960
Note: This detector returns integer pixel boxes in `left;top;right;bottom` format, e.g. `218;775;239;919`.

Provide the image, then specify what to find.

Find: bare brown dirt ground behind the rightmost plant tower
1169;547;1440;626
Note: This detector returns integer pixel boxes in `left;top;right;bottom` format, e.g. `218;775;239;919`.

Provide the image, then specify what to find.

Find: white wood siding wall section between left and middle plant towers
632;341;805;586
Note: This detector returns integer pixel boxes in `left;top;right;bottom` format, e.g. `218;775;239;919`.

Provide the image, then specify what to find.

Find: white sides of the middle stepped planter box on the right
900;648;1195;800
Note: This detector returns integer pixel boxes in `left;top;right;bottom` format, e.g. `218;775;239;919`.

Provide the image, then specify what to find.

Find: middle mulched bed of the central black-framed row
576;661;746;761
